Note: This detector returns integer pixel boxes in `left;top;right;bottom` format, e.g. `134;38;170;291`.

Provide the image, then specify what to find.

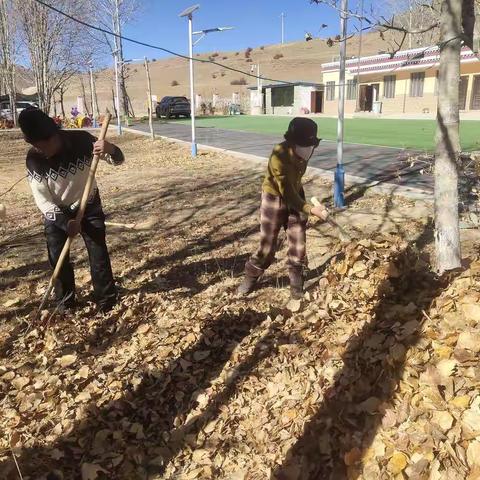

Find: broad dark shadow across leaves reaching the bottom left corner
0;309;267;479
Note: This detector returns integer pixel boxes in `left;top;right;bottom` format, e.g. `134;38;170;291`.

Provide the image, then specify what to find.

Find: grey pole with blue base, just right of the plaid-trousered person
333;0;348;208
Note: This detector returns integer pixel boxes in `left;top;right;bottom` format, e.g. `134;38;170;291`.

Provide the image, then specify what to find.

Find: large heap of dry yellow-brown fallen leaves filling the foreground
0;233;480;479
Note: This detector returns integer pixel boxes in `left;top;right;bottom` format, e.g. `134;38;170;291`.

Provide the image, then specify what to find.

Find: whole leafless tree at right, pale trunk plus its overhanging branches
312;0;479;273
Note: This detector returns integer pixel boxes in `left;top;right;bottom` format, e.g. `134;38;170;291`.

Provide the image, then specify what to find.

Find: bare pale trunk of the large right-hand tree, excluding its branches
435;0;463;273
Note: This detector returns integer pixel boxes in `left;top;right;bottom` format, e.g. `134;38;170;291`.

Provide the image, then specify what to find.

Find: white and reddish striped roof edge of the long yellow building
322;45;480;75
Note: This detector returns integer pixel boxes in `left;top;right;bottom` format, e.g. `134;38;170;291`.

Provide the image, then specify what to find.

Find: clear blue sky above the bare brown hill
122;0;368;58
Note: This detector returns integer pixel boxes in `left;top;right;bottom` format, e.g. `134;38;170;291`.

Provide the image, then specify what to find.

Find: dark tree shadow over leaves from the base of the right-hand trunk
271;229;455;480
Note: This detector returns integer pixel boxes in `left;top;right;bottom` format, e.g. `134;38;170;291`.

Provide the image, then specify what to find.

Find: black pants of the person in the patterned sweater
45;193;117;308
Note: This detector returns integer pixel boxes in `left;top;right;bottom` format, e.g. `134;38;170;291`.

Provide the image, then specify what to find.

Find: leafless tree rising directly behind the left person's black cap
15;0;92;113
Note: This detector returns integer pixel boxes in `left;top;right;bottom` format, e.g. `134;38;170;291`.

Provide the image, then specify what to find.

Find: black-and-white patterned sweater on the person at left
26;130;124;230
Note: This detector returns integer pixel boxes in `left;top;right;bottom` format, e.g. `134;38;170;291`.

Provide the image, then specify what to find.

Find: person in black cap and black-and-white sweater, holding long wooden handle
18;108;124;312
